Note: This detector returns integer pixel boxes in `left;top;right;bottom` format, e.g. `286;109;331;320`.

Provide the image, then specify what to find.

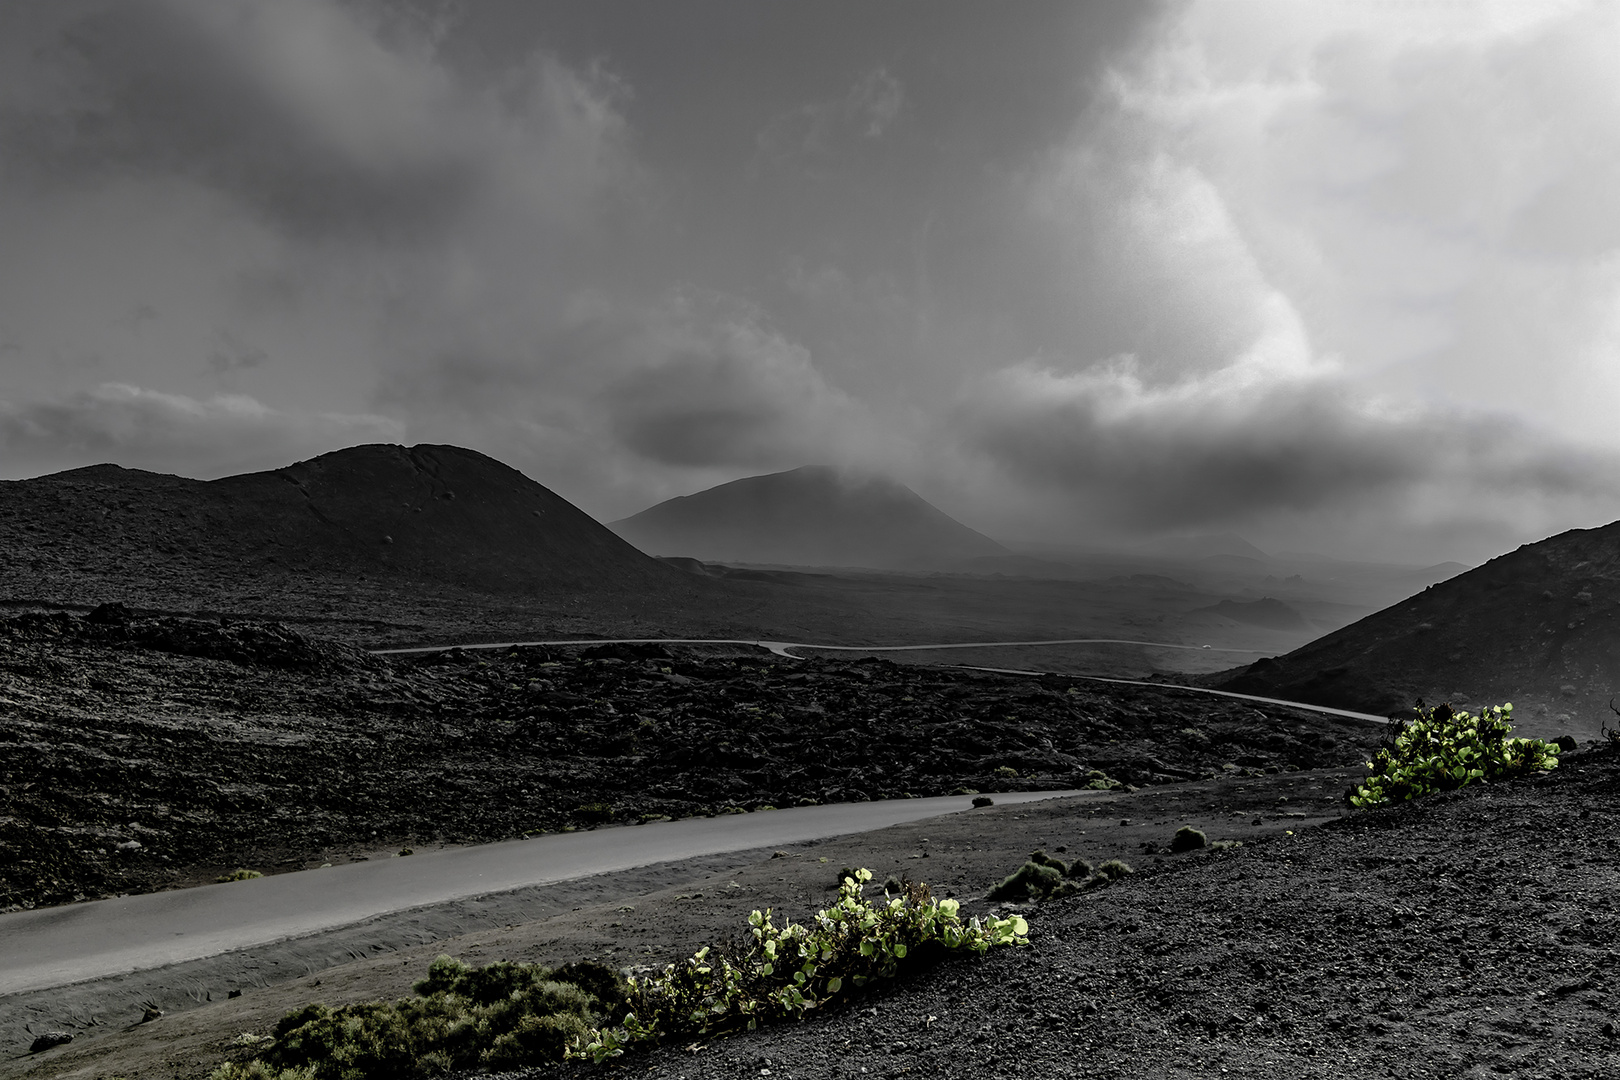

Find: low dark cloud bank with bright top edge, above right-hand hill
959;363;1620;529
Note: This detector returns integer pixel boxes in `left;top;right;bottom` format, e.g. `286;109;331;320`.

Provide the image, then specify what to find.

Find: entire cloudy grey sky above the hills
0;0;1620;563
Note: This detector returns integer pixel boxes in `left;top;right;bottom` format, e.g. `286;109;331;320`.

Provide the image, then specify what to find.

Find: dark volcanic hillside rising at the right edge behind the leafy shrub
1204;521;1620;735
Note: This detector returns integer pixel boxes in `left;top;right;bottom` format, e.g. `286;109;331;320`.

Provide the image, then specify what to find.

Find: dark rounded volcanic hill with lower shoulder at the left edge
0;445;690;621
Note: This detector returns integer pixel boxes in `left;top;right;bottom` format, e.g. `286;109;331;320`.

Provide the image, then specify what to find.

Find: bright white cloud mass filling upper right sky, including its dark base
961;3;1620;549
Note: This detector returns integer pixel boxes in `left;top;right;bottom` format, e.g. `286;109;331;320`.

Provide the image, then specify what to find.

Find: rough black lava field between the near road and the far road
0;610;1379;908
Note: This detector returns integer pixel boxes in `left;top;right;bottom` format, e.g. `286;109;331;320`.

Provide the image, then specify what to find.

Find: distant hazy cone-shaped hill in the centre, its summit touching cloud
609;466;1008;570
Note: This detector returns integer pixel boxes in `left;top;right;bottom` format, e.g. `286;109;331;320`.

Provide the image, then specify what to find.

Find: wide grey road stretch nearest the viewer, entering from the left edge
0;792;1106;996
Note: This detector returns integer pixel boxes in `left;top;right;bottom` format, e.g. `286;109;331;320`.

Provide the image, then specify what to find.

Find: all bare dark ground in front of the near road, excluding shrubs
19;750;1620;1080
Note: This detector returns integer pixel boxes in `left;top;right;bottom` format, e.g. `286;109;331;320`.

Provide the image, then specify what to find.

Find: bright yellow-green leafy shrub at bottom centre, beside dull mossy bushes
569;870;1029;1062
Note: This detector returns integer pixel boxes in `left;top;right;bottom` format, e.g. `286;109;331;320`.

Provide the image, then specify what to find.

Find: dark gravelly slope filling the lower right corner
527;750;1620;1080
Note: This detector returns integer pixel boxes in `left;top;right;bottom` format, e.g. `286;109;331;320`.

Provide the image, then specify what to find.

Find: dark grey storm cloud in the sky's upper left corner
0;0;480;238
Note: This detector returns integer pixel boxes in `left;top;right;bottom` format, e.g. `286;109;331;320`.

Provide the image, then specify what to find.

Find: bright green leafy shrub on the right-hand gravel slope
1348;701;1558;810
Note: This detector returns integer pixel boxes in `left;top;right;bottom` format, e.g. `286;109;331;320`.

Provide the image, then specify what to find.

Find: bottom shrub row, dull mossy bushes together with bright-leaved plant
218;870;1029;1080
